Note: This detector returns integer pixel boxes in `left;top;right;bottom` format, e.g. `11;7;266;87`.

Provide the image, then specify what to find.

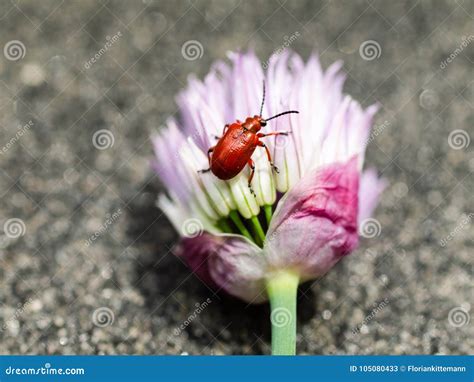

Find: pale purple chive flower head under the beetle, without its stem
153;51;384;308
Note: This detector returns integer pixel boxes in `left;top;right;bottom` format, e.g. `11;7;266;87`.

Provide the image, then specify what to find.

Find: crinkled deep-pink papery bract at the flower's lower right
264;157;359;279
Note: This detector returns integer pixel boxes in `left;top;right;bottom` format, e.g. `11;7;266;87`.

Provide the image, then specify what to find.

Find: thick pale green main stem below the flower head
267;271;299;355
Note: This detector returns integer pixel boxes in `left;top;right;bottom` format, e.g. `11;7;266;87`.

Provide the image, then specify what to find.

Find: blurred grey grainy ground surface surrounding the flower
0;0;474;354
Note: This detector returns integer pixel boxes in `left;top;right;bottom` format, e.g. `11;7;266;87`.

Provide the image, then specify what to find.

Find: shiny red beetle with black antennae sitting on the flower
200;83;298;195
